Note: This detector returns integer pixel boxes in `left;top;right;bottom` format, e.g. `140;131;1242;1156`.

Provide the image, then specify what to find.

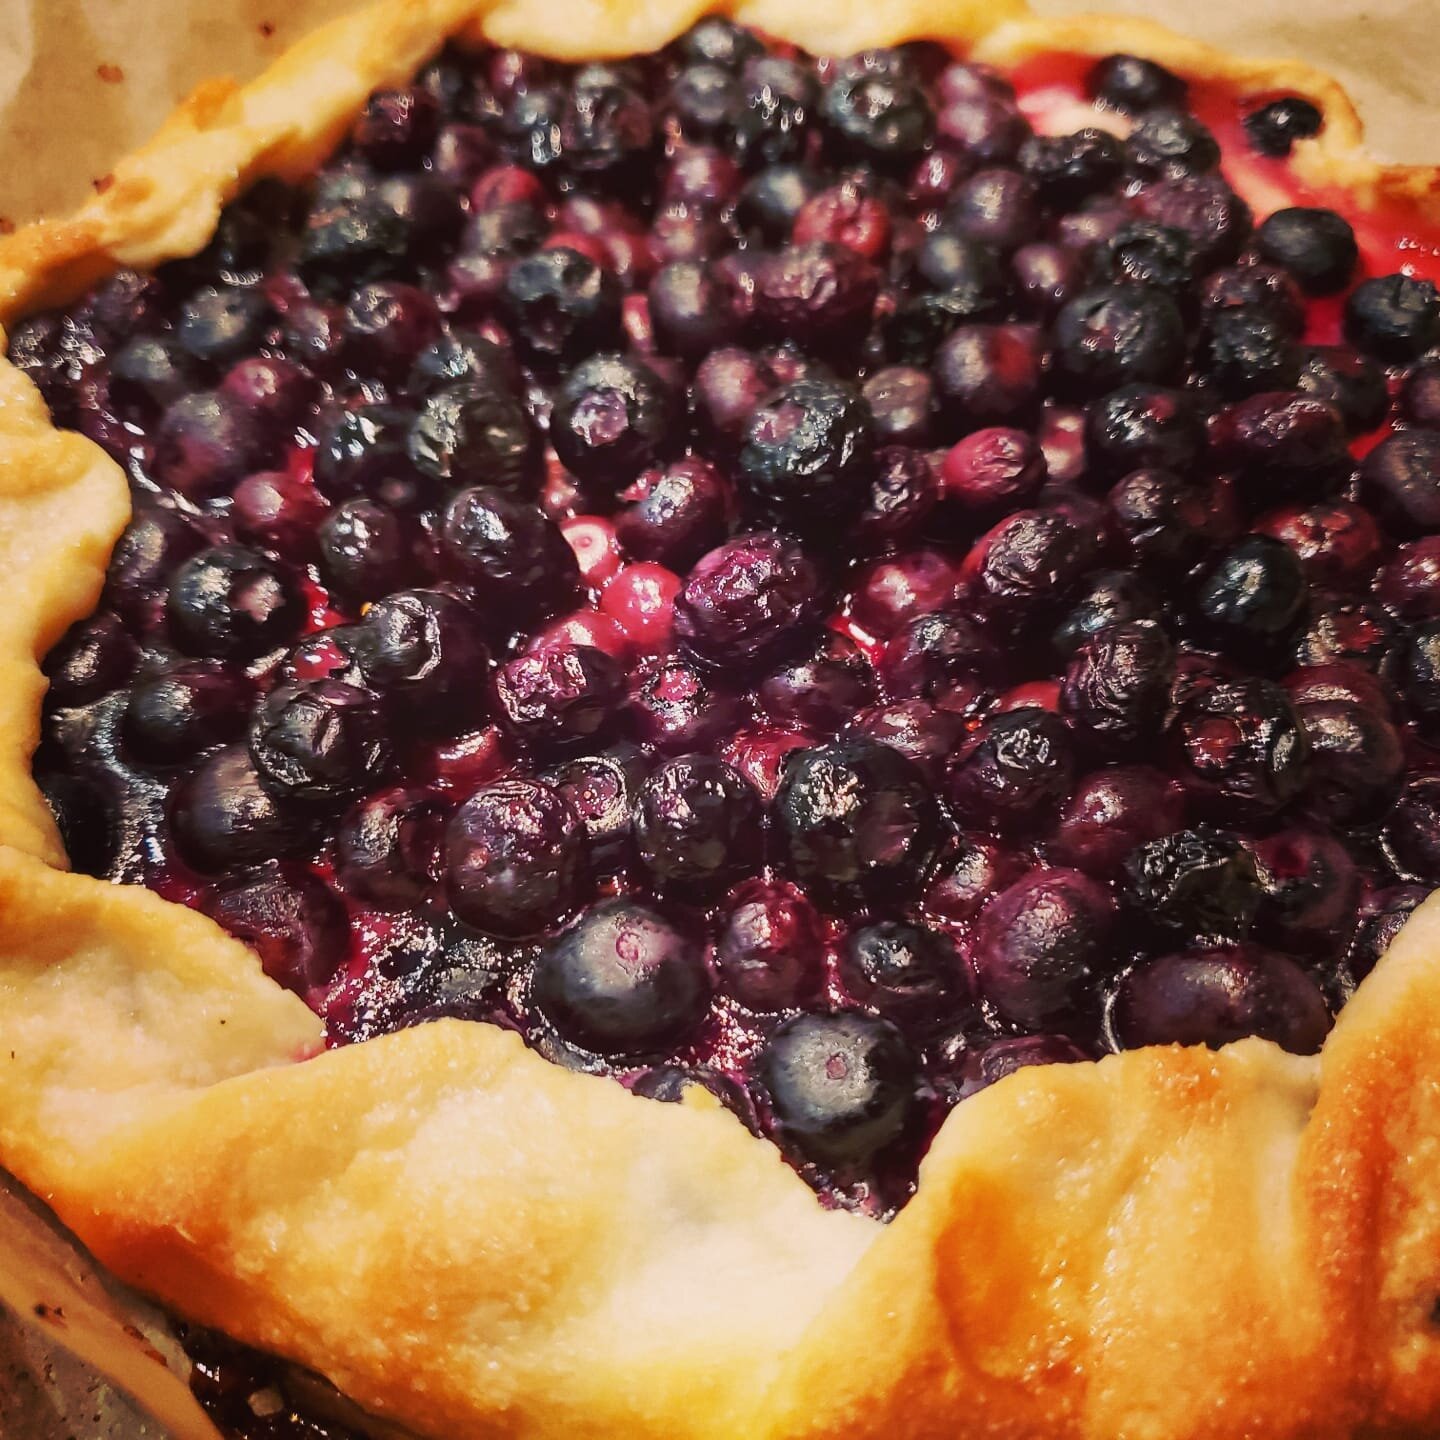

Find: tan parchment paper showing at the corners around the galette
0;0;1440;1440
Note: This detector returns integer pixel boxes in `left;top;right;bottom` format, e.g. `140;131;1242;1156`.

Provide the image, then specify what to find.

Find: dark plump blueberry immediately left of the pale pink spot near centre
439;485;580;621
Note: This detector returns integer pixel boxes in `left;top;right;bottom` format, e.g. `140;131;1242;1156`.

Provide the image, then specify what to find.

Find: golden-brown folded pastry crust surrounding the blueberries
0;0;1440;1440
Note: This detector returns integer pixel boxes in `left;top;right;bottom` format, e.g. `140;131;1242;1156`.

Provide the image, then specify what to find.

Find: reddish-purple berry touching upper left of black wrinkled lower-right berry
1044;765;1185;880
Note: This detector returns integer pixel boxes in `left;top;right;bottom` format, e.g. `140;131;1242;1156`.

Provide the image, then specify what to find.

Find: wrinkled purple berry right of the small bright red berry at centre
675;531;825;668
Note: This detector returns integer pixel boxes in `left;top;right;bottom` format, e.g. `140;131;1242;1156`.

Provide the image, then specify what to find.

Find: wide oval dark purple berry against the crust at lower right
1112;945;1331;1056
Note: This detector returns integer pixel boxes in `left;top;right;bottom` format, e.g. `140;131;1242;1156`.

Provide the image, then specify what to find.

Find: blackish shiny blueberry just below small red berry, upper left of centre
500;246;621;363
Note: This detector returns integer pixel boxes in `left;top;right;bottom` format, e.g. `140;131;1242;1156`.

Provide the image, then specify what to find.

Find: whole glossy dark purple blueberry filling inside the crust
10;19;1440;1261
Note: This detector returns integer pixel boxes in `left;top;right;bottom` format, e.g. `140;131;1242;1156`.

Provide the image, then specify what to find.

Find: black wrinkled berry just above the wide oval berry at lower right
1122;829;1263;943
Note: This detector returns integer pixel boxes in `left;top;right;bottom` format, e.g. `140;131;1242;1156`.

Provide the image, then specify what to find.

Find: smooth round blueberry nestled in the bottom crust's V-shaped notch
759;1012;920;1169
